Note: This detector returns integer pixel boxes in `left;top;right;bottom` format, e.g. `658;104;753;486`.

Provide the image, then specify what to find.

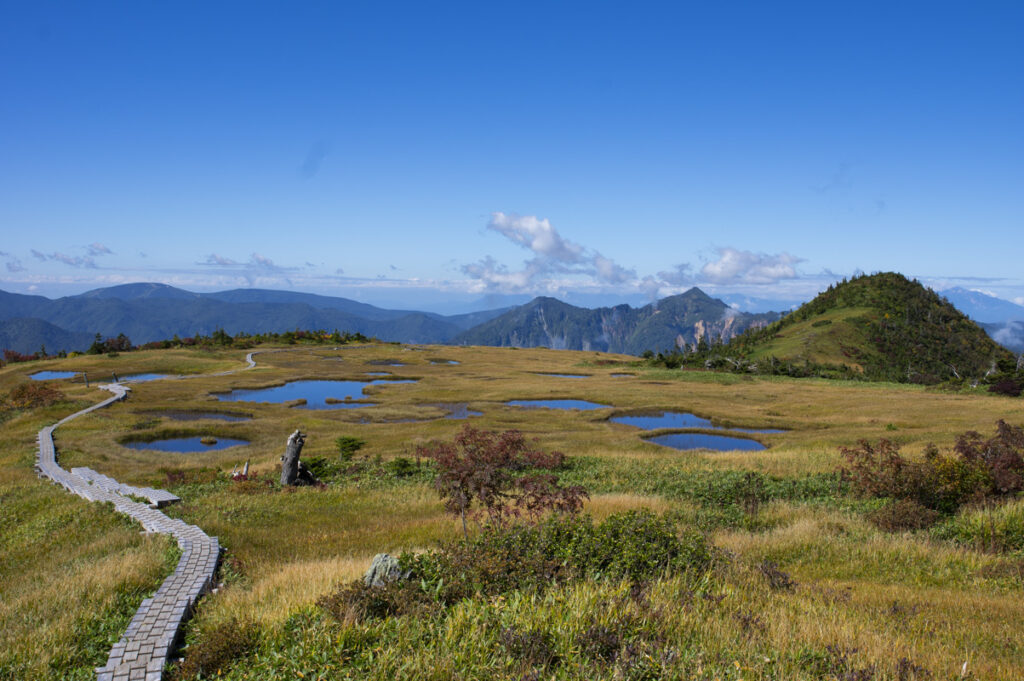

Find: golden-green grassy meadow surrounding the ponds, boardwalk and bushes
0;336;1024;681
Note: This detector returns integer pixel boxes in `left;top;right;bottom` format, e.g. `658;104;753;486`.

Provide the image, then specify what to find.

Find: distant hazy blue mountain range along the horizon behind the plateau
0;283;1024;354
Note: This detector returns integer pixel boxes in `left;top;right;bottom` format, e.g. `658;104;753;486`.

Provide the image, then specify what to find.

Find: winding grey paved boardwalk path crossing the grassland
36;350;264;681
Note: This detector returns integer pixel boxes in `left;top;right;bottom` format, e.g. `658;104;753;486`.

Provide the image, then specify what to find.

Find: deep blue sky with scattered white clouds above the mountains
0;1;1024;310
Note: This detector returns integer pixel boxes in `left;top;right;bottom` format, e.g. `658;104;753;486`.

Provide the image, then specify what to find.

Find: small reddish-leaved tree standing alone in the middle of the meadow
416;425;590;539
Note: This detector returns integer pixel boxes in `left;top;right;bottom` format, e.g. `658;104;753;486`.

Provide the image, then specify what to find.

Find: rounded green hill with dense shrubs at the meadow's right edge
727;272;1014;383
